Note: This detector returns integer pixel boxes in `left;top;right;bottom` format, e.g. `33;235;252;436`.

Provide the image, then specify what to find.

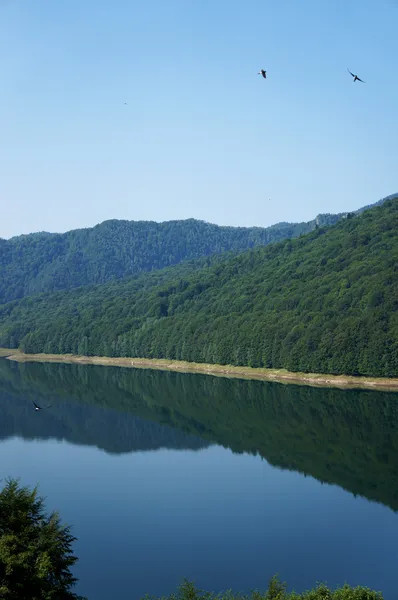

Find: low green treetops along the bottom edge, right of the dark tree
145;577;383;600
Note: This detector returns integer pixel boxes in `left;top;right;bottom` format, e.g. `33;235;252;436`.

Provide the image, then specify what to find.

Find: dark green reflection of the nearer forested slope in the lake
0;360;398;510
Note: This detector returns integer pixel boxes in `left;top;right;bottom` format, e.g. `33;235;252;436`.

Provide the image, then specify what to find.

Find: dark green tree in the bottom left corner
0;480;84;600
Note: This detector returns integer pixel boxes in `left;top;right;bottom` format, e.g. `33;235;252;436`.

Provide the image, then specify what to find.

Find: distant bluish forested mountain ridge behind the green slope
0;195;390;304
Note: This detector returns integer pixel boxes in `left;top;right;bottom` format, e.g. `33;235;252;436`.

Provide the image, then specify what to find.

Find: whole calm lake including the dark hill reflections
0;359;398;600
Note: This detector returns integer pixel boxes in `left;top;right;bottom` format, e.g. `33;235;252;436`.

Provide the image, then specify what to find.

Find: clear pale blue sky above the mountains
0;0;398;237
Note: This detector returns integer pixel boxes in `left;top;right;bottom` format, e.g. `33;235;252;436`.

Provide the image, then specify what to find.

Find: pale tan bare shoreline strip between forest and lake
0;348;398;392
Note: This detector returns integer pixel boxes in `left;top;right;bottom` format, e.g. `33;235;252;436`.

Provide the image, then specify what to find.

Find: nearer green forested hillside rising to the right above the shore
0;199;398;377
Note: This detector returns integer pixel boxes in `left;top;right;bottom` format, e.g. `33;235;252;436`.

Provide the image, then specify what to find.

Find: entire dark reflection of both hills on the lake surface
0;359;398;510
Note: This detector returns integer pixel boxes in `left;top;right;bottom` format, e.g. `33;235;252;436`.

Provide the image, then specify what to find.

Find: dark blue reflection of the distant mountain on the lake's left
0;366;209;454
